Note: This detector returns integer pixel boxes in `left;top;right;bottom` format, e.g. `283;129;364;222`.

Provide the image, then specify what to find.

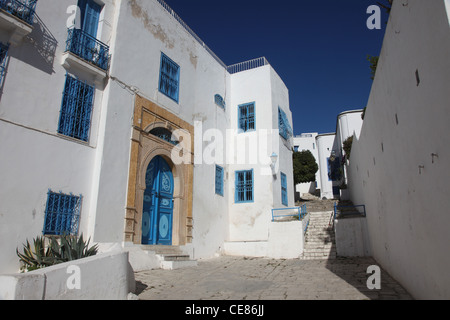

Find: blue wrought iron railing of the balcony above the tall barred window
66;28;110;71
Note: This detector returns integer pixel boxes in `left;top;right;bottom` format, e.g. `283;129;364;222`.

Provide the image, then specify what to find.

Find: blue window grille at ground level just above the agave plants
43;190;83;235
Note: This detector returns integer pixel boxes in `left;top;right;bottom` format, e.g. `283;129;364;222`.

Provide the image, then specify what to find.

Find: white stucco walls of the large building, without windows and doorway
0;0;294;273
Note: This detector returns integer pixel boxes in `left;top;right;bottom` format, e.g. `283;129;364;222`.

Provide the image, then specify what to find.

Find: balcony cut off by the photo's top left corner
0;0;37;46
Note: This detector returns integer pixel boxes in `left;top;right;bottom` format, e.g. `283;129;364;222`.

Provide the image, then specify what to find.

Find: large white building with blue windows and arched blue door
0;0;294;272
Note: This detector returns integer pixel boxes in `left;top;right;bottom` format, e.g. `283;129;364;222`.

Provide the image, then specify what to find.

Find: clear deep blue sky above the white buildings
165;0;387;135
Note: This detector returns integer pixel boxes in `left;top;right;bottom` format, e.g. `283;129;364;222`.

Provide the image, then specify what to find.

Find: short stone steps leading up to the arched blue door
142;245;197;270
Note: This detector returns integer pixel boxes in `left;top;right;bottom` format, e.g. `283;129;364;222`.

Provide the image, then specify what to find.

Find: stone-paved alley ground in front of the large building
135;256;411;300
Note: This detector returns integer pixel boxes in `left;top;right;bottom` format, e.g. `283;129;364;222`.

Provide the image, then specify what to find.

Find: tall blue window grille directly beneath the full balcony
58;74;95;142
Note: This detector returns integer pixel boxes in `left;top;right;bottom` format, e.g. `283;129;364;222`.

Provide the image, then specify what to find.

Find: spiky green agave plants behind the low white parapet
16;235;98;272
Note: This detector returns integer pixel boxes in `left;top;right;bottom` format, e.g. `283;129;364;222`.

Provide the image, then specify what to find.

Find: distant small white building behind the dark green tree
294;132;320;197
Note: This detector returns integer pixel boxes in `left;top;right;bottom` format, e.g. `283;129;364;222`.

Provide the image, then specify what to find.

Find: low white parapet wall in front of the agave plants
0;252;135;300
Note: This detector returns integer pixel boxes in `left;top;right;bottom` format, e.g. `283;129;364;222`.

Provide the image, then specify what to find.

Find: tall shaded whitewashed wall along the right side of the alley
349;0;450;299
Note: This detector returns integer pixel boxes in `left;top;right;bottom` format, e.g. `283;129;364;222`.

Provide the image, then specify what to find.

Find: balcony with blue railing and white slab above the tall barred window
62;28;110;83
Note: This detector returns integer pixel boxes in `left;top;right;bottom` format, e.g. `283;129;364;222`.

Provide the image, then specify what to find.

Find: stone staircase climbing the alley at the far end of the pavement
301;211;336;260
